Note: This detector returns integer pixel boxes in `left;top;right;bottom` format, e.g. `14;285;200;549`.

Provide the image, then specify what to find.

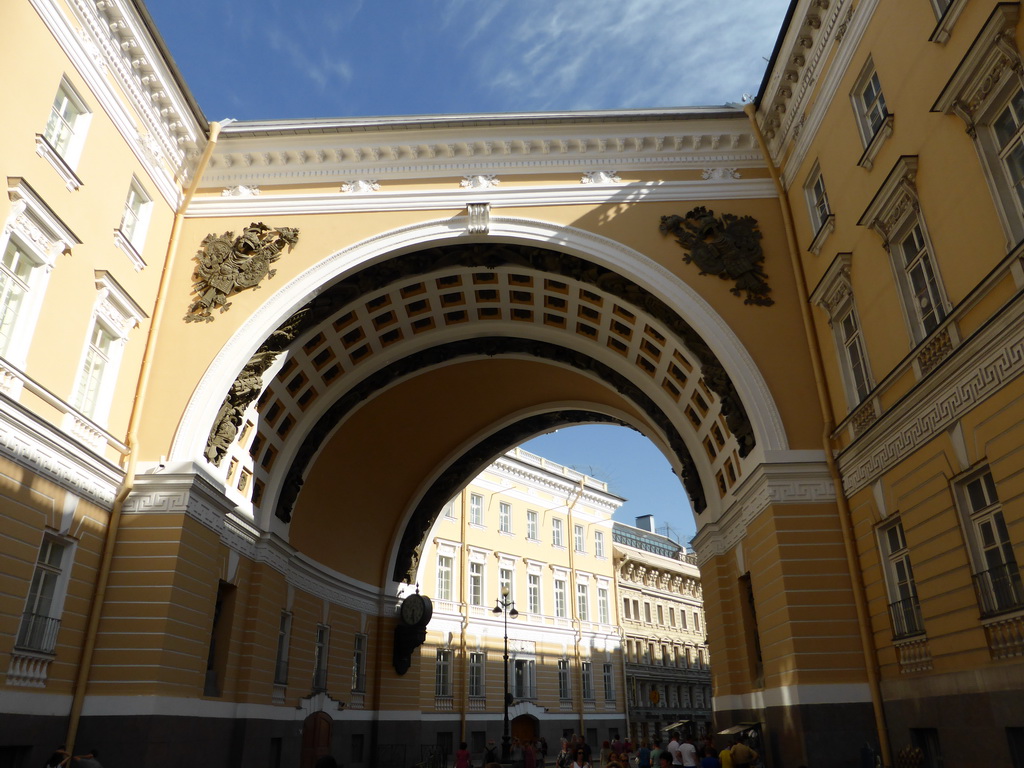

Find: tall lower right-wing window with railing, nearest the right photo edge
957;467;1024;616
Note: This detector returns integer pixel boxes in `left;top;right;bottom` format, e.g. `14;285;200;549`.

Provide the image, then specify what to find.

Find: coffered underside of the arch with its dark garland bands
190;231;778;578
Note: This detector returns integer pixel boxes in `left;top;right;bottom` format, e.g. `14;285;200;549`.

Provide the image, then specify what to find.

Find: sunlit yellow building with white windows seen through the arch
409;449;628;759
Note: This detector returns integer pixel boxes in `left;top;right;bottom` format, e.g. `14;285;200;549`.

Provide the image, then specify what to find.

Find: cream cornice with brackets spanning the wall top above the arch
204;110;764;186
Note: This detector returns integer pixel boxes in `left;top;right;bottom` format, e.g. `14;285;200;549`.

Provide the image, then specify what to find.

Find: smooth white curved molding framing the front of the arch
168;216;788;465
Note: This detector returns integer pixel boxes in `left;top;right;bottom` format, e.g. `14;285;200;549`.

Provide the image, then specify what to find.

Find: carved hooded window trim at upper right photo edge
932;3;1024;246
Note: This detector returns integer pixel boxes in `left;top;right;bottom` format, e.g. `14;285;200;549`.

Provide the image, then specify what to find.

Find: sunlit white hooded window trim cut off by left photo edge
0;178;82;385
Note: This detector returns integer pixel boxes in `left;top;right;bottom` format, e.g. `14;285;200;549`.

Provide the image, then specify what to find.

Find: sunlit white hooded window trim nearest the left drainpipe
65;270;146;433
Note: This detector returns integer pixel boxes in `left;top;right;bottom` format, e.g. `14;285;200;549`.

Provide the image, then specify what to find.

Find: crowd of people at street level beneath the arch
475;732;762;768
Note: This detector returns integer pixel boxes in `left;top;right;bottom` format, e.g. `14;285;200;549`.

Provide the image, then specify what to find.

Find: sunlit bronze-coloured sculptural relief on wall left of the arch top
184;221;299;323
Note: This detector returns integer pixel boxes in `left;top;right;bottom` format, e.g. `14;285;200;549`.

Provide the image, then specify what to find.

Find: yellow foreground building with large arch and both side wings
0;0;1024;766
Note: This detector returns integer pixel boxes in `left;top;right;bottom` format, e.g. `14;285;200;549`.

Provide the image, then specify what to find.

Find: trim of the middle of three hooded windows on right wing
857;155;951;346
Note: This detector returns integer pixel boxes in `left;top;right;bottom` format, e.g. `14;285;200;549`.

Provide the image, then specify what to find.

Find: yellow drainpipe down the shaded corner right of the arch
743;103;892;766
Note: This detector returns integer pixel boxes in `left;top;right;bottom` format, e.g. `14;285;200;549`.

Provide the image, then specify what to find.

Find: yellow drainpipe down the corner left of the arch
65;120;226;755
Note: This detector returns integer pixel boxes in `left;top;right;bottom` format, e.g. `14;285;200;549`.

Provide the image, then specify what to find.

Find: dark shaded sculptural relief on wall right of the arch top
660;206;775;306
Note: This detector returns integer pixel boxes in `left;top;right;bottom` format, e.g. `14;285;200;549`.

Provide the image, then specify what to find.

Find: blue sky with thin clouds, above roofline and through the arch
146;0;790;542
